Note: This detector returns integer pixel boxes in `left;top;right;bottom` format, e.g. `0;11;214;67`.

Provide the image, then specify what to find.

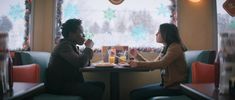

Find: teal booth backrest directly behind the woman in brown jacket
185;50;216;83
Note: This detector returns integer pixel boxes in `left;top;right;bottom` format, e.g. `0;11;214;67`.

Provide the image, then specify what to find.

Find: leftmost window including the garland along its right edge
0;0;31;50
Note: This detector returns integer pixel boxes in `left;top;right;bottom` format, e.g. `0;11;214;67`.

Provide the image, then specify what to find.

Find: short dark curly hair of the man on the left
61;19;82;38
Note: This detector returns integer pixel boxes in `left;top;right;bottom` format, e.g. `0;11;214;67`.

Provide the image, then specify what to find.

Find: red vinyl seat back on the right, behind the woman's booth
192;62;215;83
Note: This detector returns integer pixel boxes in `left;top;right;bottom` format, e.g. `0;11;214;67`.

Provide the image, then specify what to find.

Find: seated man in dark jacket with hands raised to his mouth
46;19;105;100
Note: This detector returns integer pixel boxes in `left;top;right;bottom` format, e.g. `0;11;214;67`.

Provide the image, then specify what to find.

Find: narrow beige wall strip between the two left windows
31;0;55;51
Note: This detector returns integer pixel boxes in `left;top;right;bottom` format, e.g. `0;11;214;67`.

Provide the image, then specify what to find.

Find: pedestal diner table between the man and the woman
80;65;153;100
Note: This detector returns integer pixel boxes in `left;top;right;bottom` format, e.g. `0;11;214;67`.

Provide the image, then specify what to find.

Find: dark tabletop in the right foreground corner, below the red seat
180;83;235;100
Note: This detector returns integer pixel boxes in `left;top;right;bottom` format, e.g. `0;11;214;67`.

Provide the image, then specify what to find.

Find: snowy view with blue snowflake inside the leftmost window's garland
0;0;25;50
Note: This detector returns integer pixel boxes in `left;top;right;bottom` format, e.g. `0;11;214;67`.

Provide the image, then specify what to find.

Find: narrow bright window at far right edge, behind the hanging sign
216;0;235;62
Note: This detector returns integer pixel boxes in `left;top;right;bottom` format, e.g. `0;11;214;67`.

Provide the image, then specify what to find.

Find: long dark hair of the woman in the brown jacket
159;23;186;54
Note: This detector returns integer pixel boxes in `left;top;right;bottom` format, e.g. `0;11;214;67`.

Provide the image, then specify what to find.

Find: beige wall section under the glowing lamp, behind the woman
178;0;217;50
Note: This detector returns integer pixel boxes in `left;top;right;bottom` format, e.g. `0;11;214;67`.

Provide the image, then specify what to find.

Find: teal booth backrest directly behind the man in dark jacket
17;51;51;82
